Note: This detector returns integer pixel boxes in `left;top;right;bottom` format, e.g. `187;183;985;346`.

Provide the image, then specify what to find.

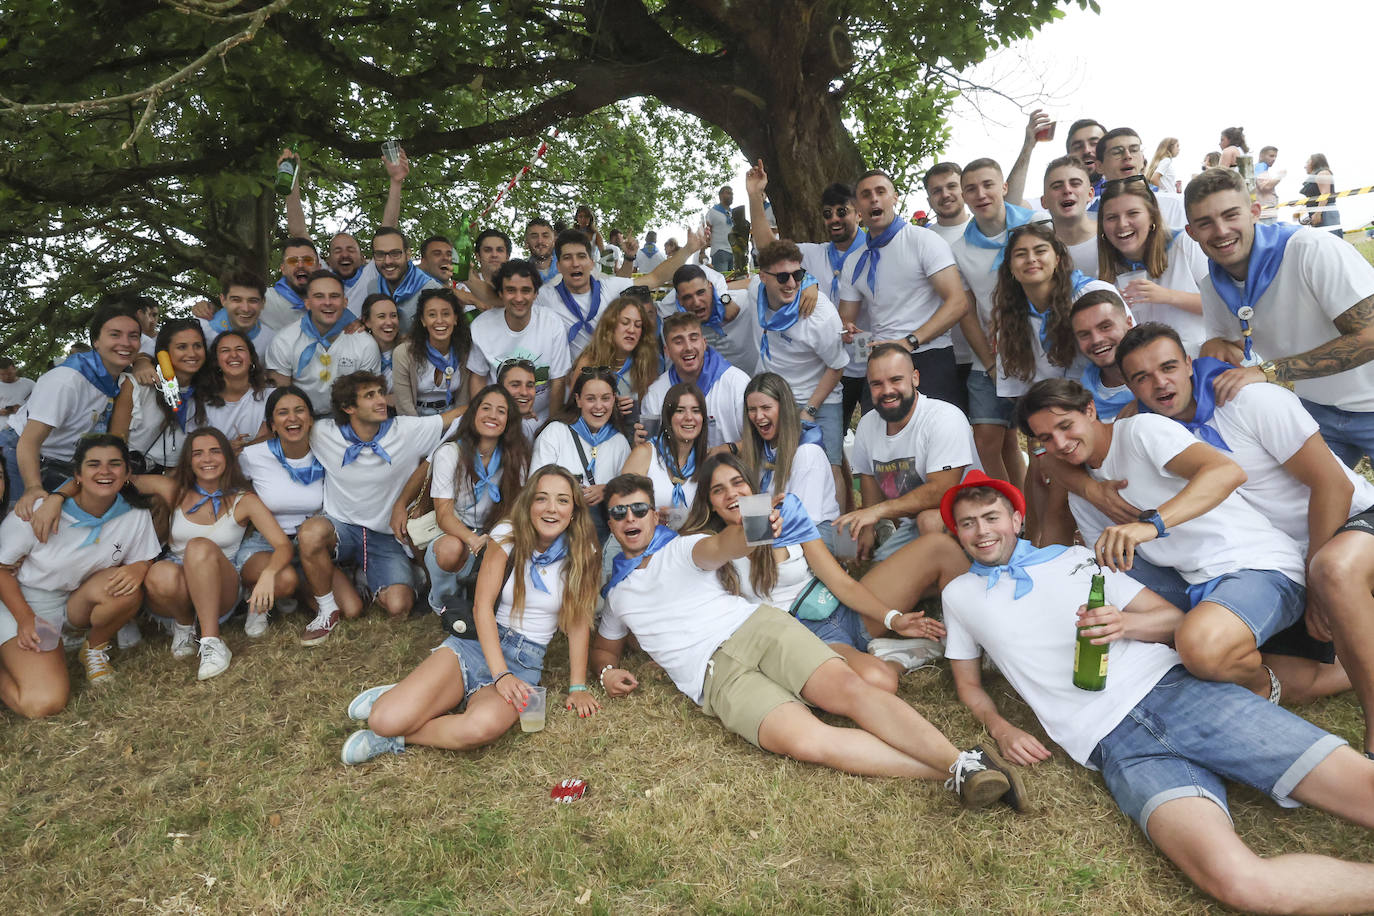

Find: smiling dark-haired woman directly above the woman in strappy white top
194;331;272;452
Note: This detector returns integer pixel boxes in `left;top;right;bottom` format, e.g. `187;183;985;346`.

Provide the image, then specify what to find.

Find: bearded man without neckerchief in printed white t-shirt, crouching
835;343;981;560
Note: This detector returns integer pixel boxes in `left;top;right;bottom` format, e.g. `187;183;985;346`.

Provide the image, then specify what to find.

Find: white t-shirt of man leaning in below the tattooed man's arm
1192;385;1374;549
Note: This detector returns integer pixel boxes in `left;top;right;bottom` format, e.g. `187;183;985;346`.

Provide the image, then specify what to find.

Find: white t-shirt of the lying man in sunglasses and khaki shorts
598;534;757;706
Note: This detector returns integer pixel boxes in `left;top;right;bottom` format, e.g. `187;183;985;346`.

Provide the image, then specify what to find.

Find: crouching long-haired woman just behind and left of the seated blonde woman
425;385;529;614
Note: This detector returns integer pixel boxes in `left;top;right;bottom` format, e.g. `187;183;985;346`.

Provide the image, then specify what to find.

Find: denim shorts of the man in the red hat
1088;665;1345;836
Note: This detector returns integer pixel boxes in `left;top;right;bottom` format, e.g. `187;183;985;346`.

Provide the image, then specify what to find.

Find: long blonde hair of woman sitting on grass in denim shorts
506;464;600;633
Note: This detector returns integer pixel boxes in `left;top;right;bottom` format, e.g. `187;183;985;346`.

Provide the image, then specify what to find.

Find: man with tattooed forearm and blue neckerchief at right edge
1184;169;1374;467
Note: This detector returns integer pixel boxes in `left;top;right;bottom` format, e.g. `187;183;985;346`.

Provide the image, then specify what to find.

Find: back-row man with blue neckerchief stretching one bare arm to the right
534;229;702;361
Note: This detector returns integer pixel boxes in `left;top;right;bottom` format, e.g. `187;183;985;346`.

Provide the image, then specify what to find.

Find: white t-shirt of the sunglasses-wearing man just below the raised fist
736;277;849;405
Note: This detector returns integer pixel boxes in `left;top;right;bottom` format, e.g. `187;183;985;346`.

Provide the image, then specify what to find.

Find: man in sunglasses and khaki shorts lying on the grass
591;474;1022;810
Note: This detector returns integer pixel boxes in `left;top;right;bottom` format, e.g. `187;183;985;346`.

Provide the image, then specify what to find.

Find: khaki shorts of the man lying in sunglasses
701;604;840;747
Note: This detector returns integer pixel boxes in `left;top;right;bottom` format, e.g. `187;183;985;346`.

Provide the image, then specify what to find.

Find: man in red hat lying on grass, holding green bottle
943;481;1374;913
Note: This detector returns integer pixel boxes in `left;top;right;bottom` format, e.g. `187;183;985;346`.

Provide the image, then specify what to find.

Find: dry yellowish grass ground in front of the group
8;617;1374;915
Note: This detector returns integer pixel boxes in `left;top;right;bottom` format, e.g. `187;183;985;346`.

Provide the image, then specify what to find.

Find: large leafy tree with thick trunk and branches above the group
0;0;1095;357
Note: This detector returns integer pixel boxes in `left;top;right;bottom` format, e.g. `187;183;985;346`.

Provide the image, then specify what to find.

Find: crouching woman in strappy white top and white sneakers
135;427;291;681
